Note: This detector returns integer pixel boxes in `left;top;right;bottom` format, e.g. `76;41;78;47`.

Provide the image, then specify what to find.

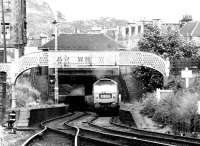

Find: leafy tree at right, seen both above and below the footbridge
133;25;198;92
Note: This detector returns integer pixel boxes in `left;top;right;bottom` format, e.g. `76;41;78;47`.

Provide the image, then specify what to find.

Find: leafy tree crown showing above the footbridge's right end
138;25;198;59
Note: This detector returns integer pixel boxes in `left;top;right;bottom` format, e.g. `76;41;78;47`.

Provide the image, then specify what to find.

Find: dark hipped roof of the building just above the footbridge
40;34;125;51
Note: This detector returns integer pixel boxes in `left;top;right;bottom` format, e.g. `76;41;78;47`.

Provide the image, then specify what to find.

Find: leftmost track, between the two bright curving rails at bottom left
22;112;88;146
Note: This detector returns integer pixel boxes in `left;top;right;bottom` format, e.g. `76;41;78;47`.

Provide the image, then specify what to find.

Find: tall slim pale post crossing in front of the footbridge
53;19;59;104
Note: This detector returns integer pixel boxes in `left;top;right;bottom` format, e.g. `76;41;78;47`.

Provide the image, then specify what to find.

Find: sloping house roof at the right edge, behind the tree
180;21;200;37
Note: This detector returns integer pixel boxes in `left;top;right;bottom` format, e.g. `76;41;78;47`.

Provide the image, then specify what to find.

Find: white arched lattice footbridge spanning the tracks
0;50;169;107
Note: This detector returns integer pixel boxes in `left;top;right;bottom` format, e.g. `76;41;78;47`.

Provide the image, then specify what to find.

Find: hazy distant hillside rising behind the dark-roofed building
27;0;127;38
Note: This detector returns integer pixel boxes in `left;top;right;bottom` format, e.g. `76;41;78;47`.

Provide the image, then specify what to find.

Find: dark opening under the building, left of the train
53;68;118;110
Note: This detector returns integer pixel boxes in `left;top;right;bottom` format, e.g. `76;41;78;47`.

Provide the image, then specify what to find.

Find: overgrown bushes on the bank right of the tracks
141;80;200;131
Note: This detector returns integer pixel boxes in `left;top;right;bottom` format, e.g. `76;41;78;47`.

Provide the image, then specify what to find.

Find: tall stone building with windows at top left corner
0;0;27;62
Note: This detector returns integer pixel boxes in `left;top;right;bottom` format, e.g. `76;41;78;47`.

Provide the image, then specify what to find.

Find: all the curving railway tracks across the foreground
22;112;200;146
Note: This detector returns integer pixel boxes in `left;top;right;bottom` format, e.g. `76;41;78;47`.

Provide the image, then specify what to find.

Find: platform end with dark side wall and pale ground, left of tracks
0;104;68;146
